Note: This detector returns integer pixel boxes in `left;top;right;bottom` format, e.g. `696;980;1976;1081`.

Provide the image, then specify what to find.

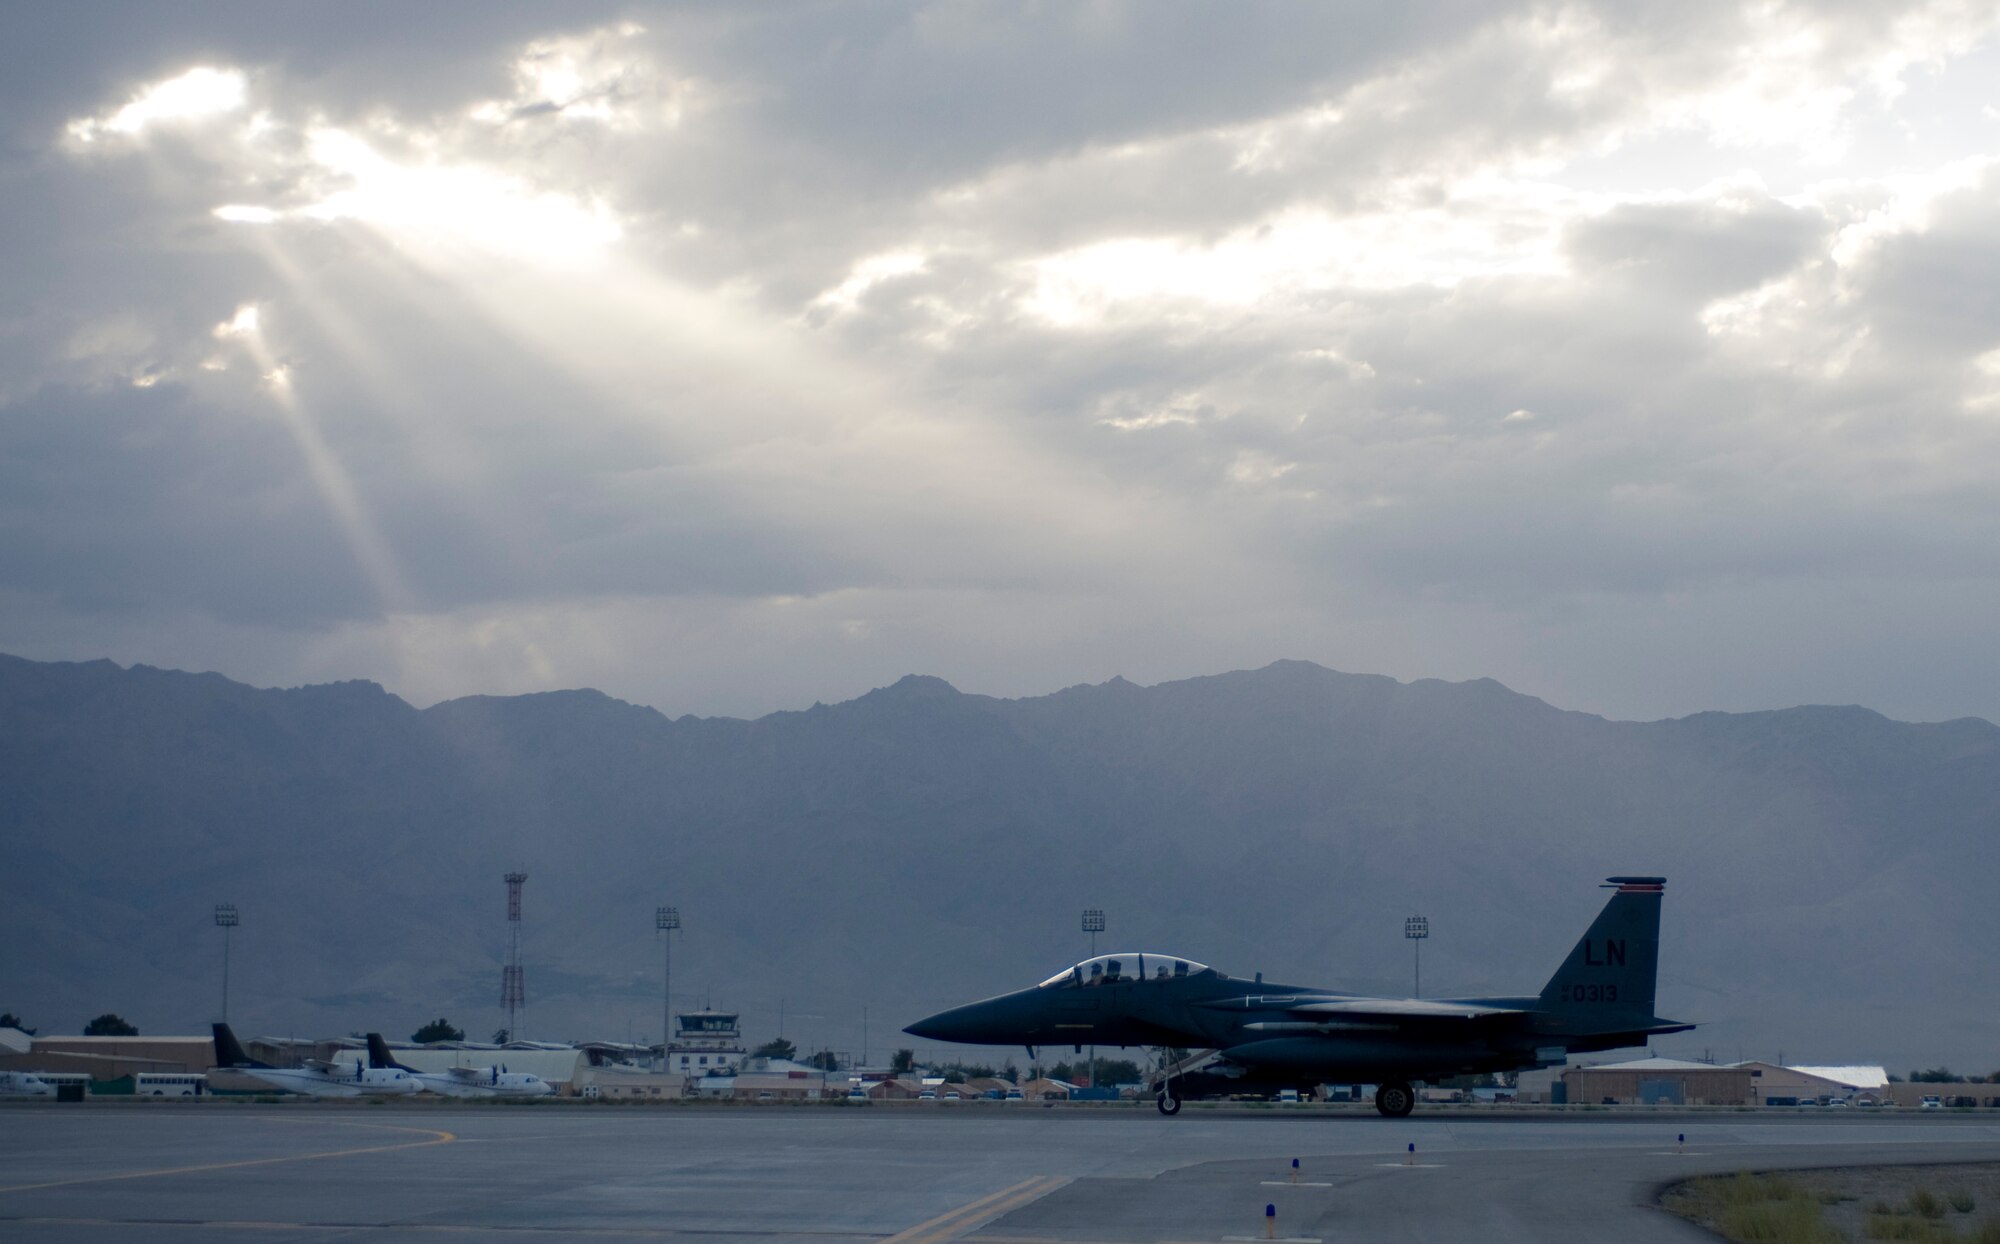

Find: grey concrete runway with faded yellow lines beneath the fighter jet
0;1102;2000;1244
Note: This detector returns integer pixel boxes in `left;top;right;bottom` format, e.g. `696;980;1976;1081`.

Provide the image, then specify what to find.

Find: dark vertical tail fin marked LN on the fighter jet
1542;876;1666;1032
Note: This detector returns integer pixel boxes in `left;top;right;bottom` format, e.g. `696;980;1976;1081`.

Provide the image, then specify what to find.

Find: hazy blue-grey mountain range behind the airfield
0;658;2000;1072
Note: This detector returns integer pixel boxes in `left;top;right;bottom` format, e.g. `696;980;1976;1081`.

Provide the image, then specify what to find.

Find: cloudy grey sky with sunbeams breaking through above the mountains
0;0;2000;720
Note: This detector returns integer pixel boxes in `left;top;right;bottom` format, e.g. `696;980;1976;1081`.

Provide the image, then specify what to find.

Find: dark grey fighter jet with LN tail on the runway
904;876;1694;1118
